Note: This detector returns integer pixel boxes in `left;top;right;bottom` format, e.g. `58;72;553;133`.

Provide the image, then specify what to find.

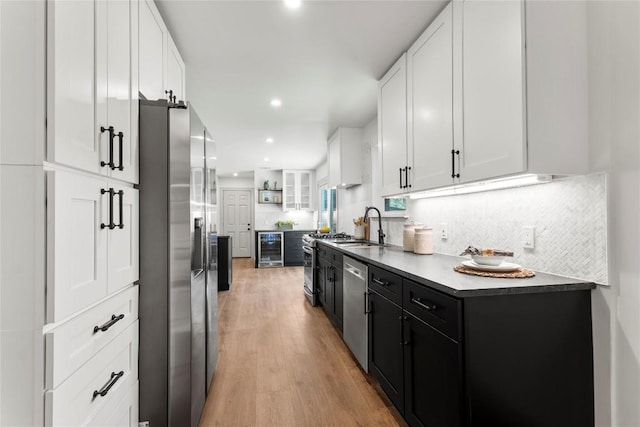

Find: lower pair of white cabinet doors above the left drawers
47;170;139;322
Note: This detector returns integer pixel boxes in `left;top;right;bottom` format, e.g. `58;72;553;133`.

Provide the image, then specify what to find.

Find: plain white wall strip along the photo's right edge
587;1;640;426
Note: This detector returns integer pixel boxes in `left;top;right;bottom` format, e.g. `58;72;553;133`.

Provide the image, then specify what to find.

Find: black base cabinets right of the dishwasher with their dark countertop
319;242;595;427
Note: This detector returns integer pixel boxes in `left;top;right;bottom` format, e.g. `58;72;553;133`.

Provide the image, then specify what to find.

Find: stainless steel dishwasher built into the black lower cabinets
342;256;369;372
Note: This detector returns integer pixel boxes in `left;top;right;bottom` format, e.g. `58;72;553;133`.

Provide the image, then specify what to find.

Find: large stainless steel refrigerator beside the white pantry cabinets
139;100;218;427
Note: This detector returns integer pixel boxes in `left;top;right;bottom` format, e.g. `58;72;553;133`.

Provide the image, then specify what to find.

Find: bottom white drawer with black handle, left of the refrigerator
45;321;138;426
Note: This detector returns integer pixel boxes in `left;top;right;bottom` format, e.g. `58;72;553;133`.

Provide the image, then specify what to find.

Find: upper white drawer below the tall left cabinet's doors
45;286;138;389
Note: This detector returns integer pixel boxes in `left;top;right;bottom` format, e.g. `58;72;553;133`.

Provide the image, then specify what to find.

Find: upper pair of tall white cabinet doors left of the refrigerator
47;0;138;182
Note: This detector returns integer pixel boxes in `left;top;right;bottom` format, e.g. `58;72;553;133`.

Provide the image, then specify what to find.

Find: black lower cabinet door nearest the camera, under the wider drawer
403;312;463;427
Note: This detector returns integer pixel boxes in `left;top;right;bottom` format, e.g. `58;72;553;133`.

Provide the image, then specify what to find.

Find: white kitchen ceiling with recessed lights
156;0;447;176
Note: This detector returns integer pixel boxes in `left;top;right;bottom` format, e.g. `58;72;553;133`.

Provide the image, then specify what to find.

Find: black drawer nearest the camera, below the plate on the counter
402;280;461;341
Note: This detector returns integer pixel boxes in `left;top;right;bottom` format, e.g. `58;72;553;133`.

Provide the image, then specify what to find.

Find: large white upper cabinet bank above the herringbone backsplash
378;0;588;196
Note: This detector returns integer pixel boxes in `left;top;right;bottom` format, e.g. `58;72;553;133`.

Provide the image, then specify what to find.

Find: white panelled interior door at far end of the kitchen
222;190;252;258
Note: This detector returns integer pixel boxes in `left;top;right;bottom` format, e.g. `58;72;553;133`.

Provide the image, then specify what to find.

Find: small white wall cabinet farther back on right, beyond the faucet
328;128;362;188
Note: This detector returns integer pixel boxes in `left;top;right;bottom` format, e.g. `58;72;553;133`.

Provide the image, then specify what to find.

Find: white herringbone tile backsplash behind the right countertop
383;174;607;284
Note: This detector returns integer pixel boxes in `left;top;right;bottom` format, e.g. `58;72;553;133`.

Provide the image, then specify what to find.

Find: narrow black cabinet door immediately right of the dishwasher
368;289;404;414
